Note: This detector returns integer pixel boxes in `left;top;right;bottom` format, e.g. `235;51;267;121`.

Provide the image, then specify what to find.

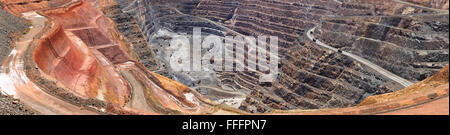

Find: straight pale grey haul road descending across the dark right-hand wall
306;26;414;87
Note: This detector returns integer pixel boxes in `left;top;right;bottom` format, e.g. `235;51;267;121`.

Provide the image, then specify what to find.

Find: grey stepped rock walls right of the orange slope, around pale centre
110;0;448;112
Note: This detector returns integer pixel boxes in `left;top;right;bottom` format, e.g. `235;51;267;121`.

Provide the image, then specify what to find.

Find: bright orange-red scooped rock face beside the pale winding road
34;3;130;104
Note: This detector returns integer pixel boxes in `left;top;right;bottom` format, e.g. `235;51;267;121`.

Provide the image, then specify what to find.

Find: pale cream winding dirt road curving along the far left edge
0;12;96;115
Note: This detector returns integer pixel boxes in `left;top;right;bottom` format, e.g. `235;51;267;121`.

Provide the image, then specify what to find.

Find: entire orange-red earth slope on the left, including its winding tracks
2;1;218;114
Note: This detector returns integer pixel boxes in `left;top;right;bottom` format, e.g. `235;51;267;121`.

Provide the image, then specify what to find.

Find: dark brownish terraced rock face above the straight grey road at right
317;2;449;81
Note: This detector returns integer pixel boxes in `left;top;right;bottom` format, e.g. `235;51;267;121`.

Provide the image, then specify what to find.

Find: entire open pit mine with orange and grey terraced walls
0;0;449;115
